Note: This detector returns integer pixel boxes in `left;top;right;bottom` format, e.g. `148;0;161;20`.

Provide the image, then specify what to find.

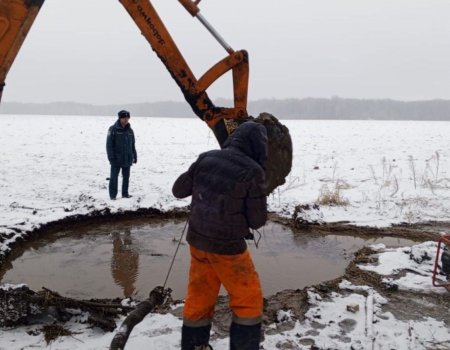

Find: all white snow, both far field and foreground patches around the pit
0;115;450;350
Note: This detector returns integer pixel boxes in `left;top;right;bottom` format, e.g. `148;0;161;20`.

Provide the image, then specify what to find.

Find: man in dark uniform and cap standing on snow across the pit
106;110;137;200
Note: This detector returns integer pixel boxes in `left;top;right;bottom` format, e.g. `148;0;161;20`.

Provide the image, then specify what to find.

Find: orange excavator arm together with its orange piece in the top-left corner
0;0;249;145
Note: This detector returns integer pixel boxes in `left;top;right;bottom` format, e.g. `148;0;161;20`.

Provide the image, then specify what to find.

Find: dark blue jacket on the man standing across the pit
106;120;137;167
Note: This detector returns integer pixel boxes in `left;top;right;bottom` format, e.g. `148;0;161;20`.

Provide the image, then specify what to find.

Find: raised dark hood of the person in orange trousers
223;121;268;169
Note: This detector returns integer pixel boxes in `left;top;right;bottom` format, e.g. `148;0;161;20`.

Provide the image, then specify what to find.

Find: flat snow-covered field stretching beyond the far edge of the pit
0;115;450;241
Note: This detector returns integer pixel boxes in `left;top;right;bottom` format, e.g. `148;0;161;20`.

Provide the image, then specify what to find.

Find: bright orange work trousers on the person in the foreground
183;246;263;327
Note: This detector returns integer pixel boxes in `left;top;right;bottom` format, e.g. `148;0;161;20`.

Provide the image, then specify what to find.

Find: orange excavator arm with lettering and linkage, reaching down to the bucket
119;0;249;145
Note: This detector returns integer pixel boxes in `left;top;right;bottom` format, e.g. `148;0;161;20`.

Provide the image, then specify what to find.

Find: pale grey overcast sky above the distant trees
3;0;450;104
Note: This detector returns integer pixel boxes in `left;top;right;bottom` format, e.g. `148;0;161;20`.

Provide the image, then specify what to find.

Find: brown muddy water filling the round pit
0;221;413;299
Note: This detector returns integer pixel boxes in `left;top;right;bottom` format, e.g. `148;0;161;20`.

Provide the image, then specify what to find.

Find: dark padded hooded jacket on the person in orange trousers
172;121;267;255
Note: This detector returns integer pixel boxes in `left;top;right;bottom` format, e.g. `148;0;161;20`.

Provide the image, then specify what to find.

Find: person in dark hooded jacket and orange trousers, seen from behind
172;121;267;350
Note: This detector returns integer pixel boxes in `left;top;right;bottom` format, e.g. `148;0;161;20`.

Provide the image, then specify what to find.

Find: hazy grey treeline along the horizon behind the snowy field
0;97;450;121
